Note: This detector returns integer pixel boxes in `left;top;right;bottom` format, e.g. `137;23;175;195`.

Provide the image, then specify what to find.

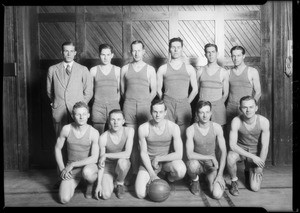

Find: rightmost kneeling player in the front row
227;96;270;196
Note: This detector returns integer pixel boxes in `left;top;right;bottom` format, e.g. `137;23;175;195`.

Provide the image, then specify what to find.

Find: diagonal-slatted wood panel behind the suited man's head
39;22;75;59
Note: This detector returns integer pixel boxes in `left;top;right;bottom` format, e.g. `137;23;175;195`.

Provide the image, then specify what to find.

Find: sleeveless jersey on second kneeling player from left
105;127;128;161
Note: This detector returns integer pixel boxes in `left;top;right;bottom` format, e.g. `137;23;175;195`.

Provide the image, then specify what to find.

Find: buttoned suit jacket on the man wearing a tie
47;61;93;122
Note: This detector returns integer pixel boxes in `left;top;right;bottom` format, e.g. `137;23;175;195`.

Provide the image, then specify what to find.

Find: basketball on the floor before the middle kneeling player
148;179;171;202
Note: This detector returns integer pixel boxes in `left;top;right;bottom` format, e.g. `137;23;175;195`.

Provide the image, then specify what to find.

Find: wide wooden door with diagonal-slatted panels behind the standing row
31;5;272;168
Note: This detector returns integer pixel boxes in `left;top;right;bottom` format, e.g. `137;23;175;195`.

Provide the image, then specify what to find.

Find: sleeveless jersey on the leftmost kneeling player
67;124;91;163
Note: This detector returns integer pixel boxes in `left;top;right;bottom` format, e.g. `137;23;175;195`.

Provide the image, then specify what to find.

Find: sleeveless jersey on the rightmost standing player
228;66;253;105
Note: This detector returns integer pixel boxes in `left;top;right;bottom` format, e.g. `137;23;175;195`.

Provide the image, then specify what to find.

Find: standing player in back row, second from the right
197;43;229;127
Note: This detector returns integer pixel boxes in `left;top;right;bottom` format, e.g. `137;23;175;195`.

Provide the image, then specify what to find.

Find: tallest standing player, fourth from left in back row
157;37;198;161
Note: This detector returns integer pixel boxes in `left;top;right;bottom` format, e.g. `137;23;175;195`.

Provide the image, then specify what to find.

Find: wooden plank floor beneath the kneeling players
4;166;293;211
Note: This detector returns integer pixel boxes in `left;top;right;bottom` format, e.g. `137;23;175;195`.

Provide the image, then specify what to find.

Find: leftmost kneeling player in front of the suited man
55;101;99;204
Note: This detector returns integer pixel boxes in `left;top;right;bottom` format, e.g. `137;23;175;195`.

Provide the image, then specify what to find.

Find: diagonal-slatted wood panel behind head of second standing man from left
86;22;122;59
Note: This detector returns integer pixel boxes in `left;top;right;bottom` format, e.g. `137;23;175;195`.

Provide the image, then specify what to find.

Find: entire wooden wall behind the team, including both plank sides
3;2;292;169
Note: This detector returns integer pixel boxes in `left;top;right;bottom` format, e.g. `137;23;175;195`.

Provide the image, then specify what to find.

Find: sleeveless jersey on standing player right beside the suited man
94;65;118;103
